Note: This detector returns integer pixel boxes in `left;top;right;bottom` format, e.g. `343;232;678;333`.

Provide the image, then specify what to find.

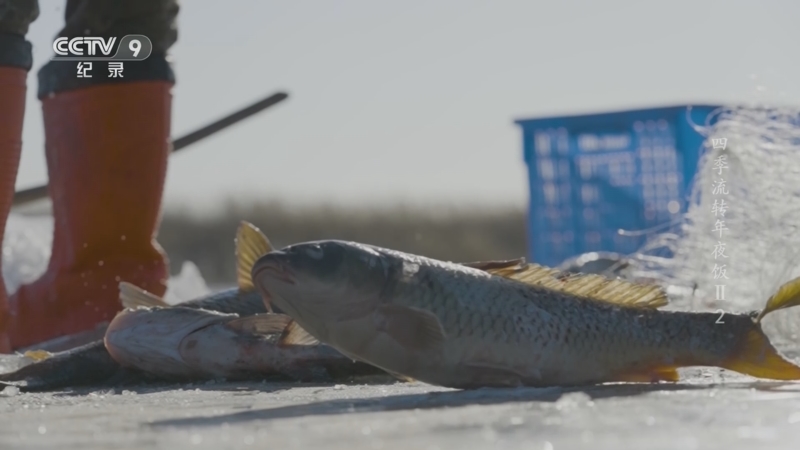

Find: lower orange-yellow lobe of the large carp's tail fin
721;325;800;380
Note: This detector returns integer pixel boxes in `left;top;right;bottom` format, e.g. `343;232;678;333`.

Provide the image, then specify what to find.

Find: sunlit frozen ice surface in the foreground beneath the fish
0;374;800;450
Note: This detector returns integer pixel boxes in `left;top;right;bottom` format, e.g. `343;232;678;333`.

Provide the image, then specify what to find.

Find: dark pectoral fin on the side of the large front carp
376;305;445;352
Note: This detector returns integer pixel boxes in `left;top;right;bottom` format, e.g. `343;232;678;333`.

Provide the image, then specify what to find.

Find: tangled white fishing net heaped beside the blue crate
633;107;800;339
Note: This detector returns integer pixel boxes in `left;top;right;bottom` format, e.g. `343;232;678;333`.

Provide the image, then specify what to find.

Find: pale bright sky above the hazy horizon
12;0;800;210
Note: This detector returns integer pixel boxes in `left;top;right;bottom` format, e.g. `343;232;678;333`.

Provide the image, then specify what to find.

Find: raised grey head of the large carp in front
252;240;397;341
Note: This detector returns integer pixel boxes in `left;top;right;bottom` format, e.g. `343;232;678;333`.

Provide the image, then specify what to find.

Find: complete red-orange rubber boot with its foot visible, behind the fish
7;81;172;349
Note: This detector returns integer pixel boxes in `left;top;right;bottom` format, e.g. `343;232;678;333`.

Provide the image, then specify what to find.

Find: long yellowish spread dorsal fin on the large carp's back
486;264;668;309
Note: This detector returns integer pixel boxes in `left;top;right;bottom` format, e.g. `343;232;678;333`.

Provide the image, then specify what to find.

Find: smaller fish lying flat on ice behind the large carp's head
105;307;385;381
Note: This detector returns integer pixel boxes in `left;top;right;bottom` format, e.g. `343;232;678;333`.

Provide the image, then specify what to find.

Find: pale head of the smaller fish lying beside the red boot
104;307;238;377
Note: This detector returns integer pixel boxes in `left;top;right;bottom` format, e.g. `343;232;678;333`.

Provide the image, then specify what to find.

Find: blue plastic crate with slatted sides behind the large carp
516;105;718;266
